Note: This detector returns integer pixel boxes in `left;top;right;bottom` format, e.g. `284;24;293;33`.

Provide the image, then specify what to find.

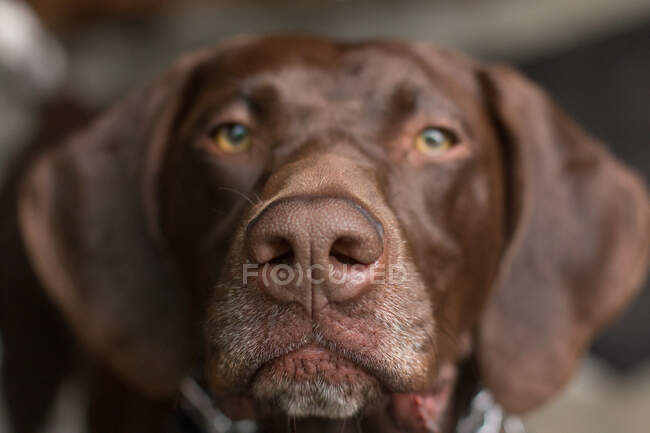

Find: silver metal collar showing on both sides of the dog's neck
175;377;526;433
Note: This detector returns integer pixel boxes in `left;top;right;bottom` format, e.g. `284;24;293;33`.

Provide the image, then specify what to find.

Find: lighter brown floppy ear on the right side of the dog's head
478;67;650;413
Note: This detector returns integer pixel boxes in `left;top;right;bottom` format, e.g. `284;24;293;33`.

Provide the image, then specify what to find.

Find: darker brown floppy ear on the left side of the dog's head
18;52;219;396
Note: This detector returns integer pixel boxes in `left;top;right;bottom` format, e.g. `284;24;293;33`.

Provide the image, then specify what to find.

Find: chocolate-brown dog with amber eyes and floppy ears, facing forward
2;37;650;432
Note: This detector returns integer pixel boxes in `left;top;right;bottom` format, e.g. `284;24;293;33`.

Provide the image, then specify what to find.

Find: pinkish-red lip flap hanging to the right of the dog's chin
391;369;456;433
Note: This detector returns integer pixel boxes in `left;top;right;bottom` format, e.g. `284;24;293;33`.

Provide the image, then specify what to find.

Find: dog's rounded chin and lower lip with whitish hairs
252;347;387;419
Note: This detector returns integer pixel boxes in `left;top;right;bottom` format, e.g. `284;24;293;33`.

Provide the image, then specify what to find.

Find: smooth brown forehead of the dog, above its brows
205;37;464;108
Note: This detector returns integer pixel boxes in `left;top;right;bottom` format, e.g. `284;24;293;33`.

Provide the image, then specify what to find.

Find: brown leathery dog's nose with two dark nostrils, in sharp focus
246;197;384;314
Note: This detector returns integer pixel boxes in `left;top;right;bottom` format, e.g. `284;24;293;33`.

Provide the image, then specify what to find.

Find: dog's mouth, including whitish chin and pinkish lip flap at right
214;345;456;426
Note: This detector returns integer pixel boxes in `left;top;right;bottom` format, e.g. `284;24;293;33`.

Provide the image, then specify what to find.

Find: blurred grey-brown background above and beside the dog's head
0;0;650;433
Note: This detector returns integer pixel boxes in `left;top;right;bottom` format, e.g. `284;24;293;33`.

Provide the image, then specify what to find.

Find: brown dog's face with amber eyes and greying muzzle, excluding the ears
160;39;504;417
